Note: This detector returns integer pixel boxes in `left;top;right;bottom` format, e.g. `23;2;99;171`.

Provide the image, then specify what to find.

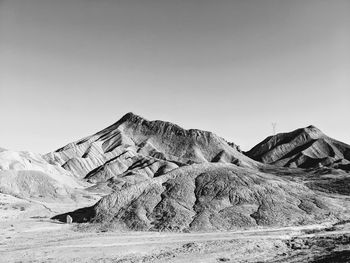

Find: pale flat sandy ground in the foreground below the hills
0;195;350;263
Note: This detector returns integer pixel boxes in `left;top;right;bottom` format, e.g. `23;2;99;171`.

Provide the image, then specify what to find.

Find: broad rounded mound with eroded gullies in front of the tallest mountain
55;163;337;231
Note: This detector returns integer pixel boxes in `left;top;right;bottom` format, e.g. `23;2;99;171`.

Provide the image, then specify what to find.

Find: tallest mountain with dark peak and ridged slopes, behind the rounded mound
45;113;256;183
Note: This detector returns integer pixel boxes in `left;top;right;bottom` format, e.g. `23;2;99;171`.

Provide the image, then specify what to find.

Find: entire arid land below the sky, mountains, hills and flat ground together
0;113;350;263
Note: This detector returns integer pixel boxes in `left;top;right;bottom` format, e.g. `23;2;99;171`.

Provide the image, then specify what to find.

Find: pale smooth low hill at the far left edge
0;149;87;200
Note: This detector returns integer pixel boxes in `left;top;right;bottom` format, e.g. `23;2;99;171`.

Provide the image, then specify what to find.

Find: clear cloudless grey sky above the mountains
0;0;350;153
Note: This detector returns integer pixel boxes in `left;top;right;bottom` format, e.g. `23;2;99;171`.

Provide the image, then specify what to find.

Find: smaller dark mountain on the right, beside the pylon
245;126;350;170
